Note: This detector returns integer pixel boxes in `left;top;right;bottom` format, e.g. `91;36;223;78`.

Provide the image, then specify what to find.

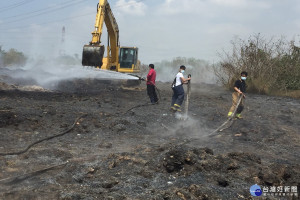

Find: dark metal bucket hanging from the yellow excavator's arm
82;45;104;67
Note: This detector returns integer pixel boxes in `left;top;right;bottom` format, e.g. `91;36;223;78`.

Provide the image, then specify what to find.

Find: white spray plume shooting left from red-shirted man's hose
1;56;138;89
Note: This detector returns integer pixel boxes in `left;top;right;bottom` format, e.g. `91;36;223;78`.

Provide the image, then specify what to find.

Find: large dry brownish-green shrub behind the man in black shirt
214;34;300;94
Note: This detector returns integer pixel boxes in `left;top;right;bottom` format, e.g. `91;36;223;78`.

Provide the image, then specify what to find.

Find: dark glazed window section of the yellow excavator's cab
119;48;137;68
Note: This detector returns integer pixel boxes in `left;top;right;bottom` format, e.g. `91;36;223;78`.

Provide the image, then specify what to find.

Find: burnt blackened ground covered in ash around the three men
0;82;300;200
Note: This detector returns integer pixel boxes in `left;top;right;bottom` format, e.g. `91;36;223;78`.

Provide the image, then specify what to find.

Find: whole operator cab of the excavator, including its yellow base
118;47;139;73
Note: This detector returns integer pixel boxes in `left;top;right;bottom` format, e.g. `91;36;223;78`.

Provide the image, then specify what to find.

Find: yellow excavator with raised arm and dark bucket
82;0;140;73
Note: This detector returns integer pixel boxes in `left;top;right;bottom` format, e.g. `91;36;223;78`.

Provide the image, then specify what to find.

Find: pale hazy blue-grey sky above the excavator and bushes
0;0;300;64
